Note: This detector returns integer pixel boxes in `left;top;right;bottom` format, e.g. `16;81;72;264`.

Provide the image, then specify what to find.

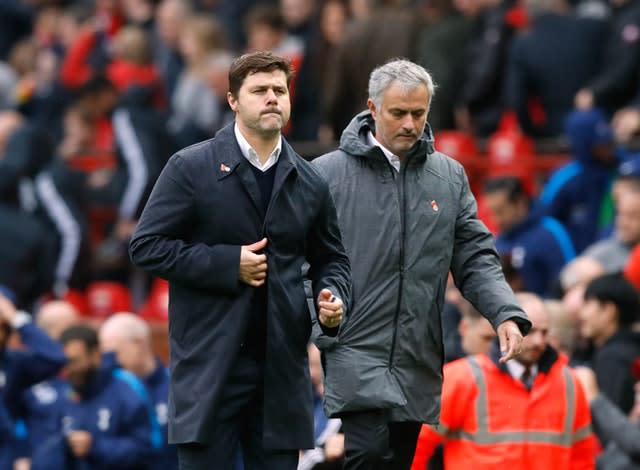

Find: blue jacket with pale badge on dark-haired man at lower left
32;366;153;470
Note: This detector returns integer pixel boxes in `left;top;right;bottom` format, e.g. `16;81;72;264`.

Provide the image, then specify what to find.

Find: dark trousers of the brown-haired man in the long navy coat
178;356;298;470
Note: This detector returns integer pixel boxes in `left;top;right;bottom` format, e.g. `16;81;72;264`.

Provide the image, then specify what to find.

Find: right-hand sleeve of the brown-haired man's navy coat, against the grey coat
307;175;351;336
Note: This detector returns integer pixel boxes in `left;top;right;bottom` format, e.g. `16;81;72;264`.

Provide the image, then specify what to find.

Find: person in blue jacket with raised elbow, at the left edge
0;294;65;469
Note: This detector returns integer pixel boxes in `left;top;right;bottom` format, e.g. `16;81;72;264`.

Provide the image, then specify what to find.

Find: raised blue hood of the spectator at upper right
565;109;613;163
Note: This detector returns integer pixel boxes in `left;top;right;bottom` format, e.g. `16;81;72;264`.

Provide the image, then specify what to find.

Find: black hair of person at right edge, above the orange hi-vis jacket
584;273;640;326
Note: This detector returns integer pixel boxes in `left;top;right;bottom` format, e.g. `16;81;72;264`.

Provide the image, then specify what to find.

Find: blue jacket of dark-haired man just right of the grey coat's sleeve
496;208;576;296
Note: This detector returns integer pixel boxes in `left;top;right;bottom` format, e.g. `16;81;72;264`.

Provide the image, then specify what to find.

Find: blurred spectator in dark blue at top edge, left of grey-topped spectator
153;0;192;101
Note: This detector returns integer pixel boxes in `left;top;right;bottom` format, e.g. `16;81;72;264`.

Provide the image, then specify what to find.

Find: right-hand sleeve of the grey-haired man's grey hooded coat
451;166;531;334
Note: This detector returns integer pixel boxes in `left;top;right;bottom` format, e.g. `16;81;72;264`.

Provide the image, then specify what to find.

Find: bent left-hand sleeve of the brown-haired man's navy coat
129;154;240;295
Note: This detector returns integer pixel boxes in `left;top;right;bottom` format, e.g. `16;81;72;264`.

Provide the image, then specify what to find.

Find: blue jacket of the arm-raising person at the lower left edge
0;322;66;470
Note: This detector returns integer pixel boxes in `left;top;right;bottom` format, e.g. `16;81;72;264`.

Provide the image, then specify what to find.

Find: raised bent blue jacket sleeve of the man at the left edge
16;323;66;390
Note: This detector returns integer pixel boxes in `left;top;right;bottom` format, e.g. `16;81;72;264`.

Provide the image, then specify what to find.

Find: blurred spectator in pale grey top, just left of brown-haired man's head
168;16;226;147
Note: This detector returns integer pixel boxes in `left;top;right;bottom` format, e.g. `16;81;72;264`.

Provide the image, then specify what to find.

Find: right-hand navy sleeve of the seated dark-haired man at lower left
88;391;153;468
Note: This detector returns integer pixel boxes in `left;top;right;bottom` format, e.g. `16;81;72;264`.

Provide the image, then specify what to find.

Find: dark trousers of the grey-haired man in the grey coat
340;410;421;470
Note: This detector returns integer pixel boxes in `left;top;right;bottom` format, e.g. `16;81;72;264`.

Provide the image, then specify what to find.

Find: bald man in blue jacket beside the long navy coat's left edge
99;312;178;470
